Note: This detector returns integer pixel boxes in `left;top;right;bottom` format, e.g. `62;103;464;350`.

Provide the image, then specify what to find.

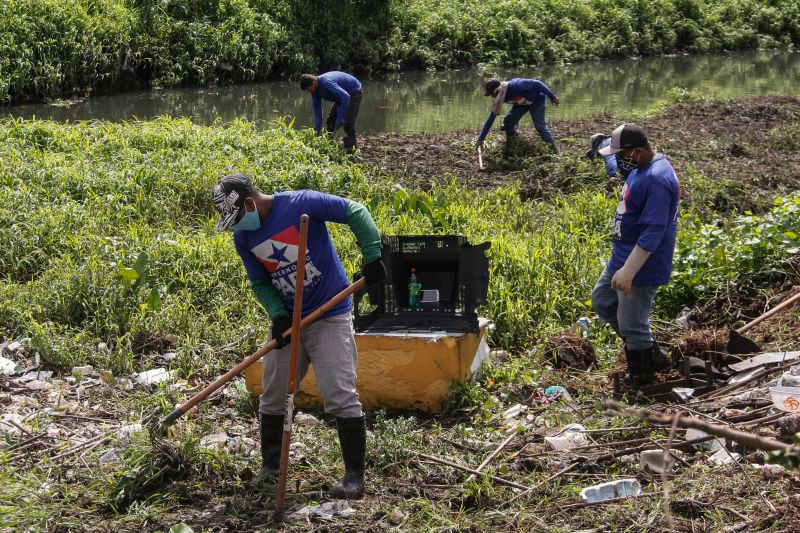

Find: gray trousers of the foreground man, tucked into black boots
259;313;364;418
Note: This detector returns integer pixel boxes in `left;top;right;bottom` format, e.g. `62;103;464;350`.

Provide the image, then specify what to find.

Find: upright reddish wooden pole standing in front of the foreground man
275;215;308;521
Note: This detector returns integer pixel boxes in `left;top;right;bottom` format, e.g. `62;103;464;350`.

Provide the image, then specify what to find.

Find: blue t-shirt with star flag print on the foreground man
233;190;352;318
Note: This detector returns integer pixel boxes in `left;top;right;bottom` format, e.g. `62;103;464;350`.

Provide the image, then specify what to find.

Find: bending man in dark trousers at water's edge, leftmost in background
300;70;364;153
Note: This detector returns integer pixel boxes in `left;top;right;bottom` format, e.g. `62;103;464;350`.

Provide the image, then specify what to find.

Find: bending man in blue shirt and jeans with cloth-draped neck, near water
475;78;560;153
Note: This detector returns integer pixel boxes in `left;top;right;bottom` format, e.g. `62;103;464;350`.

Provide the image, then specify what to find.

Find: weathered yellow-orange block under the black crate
245;319;489;412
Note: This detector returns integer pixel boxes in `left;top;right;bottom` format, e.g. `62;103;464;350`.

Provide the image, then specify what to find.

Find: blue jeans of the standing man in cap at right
592;268;658;350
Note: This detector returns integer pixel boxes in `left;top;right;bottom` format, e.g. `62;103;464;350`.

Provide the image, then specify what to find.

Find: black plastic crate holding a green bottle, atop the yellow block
355;235;490;331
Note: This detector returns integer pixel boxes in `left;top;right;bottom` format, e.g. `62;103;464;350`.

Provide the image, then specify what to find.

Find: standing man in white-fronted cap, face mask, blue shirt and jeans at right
592;124;680;387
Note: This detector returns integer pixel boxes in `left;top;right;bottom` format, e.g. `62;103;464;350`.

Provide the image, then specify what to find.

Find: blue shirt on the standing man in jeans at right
607;154;680;286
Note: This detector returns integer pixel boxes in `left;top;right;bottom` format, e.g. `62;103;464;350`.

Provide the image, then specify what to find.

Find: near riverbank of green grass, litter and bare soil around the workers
0;98;800;533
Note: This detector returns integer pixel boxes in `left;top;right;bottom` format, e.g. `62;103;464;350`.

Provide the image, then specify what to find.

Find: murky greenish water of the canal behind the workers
6;51;800;133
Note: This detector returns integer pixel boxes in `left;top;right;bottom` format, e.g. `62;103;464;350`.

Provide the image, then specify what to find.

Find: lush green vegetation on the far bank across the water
0;0;800;103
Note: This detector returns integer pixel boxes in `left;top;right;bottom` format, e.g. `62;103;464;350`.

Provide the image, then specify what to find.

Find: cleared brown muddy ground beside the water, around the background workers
360;96;800;212
